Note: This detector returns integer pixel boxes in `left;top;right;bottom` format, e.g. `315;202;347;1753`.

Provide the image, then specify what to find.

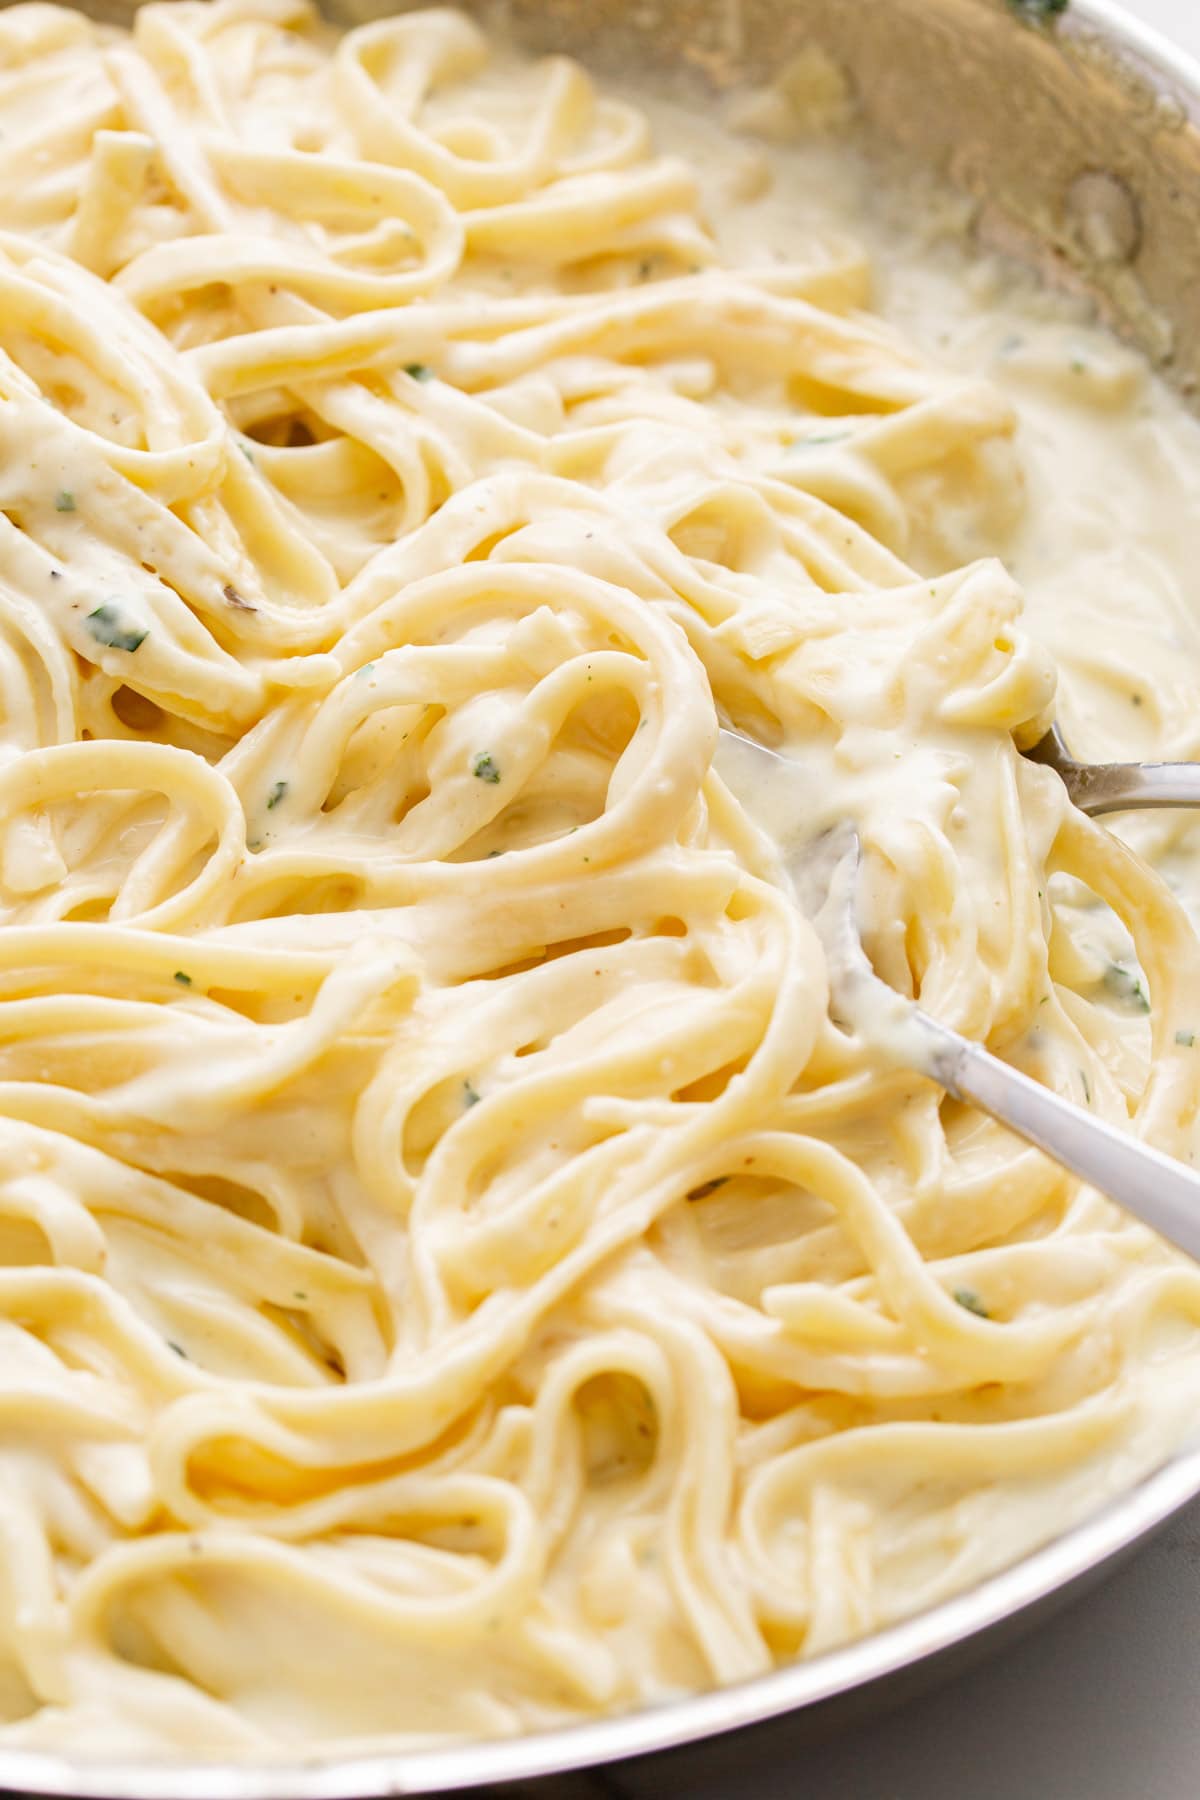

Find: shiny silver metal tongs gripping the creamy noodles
721;731;1200;1260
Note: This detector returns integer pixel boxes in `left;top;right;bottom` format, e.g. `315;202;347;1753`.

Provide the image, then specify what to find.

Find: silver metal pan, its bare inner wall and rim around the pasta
0;0;1200;1800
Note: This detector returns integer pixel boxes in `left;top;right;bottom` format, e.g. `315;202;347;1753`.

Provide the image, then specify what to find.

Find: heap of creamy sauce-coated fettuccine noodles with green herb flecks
0;0;1200;1757
